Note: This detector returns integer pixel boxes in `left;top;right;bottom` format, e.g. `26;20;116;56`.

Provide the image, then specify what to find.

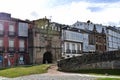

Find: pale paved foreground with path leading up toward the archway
0;66;120;80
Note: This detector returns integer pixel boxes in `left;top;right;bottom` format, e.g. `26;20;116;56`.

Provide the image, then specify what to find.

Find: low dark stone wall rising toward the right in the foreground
58;51;120;71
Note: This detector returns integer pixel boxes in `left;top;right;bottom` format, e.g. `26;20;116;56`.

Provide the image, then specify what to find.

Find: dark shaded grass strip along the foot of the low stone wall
61;69;120;76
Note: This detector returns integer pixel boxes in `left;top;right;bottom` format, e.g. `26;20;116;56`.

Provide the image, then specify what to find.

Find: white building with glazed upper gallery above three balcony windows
62;26;83;58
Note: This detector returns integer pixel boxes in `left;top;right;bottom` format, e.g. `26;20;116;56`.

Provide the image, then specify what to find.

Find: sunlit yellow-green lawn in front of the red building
0;64;50;78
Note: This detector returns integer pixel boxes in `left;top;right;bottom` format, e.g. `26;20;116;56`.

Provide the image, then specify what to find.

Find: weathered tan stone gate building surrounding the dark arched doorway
28;18;61;64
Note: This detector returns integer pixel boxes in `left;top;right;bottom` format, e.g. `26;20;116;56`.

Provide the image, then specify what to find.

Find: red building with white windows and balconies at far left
0;13;29;67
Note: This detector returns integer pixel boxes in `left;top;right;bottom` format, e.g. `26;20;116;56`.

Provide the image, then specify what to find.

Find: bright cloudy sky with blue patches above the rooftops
0;0;120;27
